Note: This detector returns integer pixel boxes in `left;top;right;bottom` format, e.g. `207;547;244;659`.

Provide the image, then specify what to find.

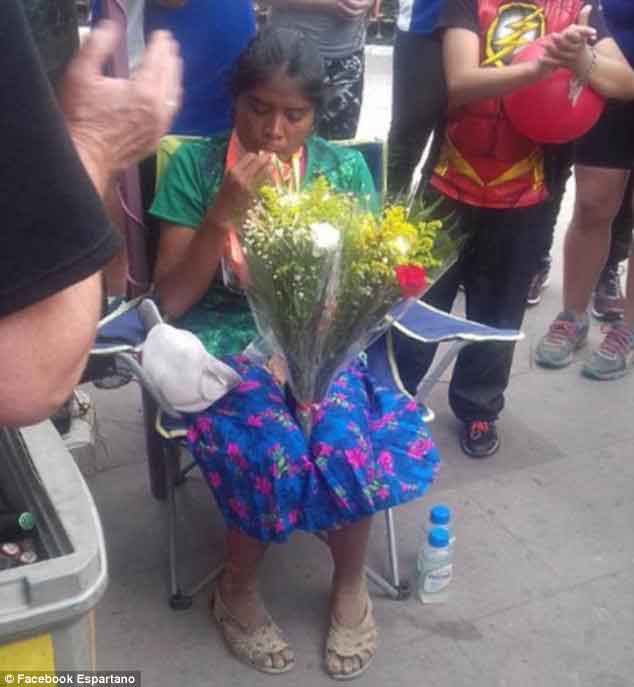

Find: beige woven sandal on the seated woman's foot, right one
325;592;378;680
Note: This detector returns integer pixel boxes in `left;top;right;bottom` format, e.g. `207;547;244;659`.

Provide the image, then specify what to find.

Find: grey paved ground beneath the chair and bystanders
81;48;634;687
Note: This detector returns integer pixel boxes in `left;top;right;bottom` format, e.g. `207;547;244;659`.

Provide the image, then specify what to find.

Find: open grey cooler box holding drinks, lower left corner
0;422;107;672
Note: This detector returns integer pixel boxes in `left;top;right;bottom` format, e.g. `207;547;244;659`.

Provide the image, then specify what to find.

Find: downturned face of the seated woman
235;71;315;161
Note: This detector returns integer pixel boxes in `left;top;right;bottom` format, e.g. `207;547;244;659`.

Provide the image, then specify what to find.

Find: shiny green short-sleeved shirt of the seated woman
150;134;378;355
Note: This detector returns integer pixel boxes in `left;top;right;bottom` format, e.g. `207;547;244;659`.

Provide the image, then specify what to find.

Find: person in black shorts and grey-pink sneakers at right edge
535;0;634;380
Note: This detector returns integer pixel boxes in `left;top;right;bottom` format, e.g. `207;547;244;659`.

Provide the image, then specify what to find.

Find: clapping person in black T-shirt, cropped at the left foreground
0;5;180;426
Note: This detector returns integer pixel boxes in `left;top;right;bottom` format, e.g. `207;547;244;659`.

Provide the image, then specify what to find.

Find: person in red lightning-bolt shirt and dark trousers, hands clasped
397;0;634;458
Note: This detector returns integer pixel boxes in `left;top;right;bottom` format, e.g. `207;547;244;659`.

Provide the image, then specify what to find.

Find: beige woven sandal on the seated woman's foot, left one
209;589;295;675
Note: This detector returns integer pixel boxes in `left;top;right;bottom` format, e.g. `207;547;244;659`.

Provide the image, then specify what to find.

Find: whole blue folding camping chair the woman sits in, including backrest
88;136;521;609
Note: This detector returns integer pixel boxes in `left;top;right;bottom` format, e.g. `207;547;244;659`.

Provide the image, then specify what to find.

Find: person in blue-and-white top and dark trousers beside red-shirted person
388;0;447;196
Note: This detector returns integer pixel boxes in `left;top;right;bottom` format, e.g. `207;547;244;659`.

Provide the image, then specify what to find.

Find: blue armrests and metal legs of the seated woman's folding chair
92;299;522;609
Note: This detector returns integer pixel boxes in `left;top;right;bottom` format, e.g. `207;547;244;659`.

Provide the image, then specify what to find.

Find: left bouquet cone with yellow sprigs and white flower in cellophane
240;180;348;398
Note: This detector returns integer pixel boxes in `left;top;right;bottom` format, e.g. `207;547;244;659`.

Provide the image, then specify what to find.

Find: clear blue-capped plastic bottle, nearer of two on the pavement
417;527;453;604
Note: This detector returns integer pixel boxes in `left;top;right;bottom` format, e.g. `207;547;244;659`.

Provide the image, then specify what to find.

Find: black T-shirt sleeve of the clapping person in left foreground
0;0;120;316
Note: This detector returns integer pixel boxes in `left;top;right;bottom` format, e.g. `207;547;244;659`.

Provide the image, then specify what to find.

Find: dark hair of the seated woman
230;27;326;110
